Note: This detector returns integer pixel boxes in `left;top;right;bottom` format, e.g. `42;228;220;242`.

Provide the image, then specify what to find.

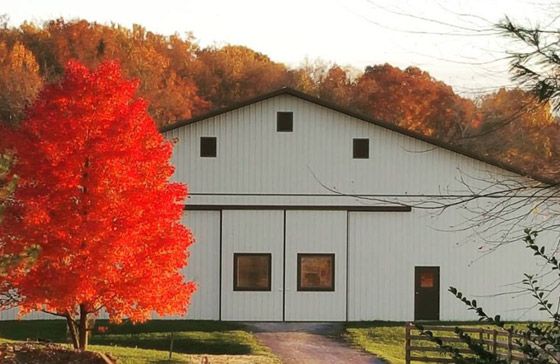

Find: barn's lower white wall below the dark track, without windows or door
0;208;555;321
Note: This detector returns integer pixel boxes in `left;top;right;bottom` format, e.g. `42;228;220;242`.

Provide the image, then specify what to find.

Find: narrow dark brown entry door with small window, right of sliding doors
414;267;439;320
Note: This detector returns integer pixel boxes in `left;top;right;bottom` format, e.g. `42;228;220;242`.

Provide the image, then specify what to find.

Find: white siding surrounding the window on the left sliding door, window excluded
221;210;284;321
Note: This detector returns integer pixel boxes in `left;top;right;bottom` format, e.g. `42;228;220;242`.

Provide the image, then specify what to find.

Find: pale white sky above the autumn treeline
0;0;560;97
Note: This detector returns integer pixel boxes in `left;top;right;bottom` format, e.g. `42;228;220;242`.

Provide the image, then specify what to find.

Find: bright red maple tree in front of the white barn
0;61;195;350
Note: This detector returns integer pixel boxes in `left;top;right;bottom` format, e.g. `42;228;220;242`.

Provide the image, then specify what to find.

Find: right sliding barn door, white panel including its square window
284;210;347;321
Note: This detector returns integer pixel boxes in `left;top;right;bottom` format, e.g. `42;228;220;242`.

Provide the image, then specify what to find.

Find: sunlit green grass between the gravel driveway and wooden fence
343;321;527;364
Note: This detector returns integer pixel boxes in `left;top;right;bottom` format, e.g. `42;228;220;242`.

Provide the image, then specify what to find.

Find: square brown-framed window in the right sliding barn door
298;254;334;291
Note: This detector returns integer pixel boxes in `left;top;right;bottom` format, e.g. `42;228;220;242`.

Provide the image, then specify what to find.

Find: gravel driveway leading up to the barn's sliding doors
246;323;384;364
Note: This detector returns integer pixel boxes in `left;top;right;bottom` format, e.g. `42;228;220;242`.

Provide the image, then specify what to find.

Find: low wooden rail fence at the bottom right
405;323;525;364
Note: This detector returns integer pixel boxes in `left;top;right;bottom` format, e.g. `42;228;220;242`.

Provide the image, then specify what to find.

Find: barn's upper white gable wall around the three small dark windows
165;95;524;204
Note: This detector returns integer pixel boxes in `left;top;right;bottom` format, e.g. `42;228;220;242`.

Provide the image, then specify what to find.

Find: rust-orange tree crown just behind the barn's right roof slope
352;64;475;141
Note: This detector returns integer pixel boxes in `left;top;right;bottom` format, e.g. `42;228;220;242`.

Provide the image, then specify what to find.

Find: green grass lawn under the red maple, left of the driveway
0;320;275;363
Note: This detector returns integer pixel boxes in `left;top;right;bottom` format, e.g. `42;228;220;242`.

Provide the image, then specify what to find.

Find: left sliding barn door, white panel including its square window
221;210;284;321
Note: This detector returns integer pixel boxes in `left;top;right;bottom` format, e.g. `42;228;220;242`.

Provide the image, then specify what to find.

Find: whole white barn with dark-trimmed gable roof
0;88;552;321
